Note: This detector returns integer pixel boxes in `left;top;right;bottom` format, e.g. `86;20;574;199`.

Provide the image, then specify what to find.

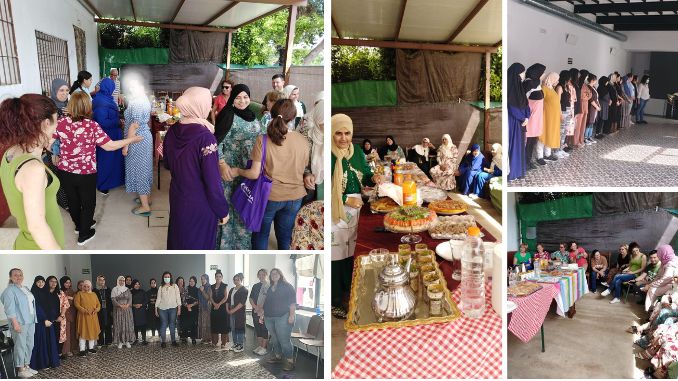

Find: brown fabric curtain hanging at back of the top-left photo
169;29;227;63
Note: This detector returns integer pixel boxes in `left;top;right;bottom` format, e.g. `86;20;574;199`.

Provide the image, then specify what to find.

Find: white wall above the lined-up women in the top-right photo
505;0;629;77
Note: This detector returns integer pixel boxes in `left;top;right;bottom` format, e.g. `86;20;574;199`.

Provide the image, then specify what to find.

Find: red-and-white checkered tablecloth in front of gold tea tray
332;282;502;379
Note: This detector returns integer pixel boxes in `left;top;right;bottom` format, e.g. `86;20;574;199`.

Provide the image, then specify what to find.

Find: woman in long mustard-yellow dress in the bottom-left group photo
74;280;101;356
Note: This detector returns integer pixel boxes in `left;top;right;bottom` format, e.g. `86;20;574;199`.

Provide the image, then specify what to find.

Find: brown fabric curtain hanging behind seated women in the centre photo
396;49;482;104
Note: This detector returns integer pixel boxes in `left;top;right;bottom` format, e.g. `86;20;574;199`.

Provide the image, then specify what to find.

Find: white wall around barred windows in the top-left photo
0;0;100;99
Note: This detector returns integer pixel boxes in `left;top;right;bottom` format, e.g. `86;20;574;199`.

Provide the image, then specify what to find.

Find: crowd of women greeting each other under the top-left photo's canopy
0;72;324;250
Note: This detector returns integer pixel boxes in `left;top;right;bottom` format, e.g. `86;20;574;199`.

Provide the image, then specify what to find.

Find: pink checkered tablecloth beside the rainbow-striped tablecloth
508;283;560;343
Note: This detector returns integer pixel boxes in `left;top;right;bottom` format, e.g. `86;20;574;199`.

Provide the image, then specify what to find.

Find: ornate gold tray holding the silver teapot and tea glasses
344;255;461;331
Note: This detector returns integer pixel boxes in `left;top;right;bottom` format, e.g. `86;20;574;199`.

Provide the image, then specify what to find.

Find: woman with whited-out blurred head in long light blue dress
122;78;153;217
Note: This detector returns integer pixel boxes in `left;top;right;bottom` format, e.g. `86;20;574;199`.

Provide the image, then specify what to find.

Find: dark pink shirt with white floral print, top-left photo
54;117;111;175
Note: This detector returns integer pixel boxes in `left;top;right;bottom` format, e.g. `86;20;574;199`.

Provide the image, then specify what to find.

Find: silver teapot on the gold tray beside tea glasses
372;255;417;323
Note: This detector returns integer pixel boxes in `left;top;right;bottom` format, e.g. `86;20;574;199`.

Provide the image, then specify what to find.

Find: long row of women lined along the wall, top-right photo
507;62;650;180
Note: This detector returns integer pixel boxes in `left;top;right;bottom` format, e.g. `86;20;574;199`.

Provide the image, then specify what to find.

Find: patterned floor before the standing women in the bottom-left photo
34;342;276;379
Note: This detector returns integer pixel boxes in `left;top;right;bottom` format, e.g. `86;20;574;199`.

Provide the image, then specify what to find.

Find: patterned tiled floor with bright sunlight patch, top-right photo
509;117;678;187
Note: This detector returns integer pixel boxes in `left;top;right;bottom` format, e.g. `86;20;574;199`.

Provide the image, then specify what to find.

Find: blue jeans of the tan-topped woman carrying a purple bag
252;199;301;250
